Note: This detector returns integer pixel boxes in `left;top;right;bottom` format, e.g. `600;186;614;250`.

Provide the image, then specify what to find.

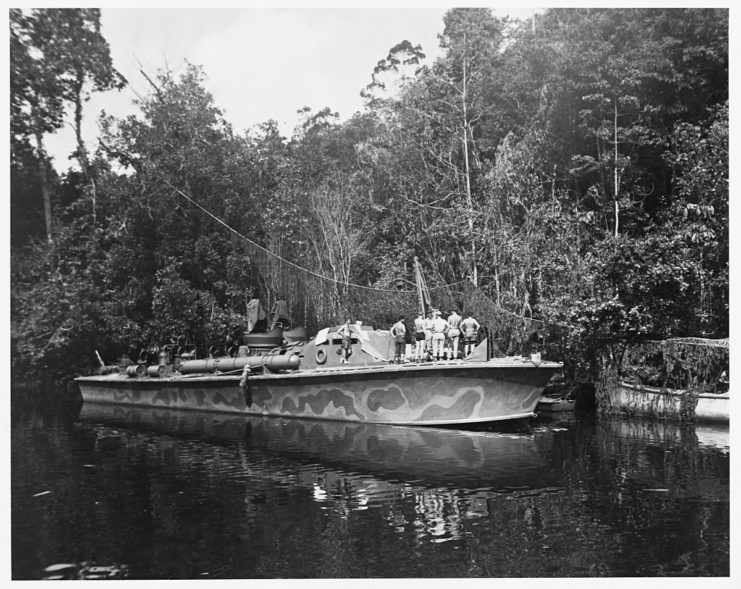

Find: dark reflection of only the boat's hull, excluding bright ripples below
80;403;548;495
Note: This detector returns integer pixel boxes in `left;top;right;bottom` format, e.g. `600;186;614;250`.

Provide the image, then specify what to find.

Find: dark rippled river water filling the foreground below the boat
11;392;730;579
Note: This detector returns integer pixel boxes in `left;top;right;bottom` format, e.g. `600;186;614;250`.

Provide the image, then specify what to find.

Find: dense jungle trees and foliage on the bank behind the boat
10;8;729;396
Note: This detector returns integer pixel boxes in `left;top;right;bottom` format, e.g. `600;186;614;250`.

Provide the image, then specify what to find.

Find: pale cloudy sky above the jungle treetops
40;2;534;171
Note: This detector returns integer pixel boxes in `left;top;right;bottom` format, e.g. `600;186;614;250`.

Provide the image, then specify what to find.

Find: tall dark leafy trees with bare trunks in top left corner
10;8;126;241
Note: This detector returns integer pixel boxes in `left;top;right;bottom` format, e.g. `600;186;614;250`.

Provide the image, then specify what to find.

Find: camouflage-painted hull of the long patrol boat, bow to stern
77;360;561;425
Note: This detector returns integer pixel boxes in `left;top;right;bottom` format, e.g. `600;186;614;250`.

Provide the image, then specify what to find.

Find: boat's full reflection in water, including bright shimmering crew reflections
80;403;563;543
